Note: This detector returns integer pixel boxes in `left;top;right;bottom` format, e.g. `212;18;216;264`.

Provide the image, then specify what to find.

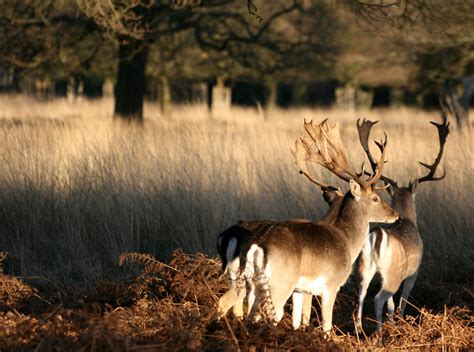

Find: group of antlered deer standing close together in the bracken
217;118;449;333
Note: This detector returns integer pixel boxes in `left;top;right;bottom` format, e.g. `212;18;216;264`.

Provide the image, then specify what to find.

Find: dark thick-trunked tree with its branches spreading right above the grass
77;0;336;121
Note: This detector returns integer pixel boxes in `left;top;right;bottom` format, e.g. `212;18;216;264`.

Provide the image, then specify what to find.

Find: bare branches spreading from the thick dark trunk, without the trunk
76;0;331;74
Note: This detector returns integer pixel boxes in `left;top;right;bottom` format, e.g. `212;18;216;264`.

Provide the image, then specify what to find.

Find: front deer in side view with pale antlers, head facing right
236;120;398;333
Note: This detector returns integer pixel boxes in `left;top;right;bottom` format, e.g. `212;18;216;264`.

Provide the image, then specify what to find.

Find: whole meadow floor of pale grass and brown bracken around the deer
0;96;474;351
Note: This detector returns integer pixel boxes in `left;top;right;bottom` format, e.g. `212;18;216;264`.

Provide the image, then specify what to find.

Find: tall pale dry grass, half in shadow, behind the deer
0;96;474;287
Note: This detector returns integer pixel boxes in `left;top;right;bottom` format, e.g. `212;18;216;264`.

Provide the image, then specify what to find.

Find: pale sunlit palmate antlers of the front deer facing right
293;119;386;189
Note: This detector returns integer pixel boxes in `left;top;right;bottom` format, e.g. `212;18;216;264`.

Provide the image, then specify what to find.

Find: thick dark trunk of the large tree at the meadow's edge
114;39;147;122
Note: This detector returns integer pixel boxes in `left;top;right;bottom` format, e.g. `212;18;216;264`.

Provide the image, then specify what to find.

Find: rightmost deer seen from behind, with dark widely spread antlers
356;116;449;332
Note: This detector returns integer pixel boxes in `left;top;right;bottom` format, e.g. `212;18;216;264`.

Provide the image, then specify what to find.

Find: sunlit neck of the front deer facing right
334;194;369;263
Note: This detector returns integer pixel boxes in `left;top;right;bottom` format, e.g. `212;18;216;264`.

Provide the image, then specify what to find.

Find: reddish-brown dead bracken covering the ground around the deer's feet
0;250;474;351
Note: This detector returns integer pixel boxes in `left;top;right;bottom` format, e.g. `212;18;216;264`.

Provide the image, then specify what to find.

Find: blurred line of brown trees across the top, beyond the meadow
0;0;474;125
